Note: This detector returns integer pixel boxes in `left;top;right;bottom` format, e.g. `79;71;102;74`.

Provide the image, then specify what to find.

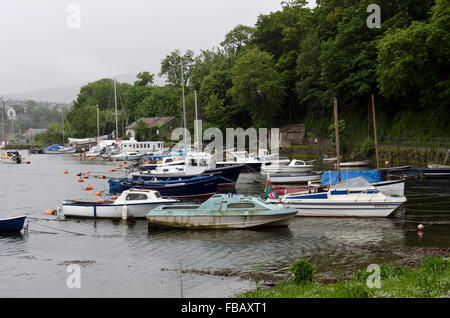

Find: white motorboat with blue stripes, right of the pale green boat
272;177;407;217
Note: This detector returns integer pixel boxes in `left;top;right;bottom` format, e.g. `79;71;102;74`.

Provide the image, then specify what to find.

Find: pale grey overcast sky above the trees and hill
0;0;315;94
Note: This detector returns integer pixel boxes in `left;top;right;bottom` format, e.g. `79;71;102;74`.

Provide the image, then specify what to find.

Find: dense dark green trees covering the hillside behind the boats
64;0;450;142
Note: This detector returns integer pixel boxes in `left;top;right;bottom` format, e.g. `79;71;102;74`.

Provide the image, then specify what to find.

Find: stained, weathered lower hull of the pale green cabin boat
147;212;296;229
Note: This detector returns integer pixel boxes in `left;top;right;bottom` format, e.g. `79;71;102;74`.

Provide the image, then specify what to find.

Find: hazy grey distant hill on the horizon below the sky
0;73;164;104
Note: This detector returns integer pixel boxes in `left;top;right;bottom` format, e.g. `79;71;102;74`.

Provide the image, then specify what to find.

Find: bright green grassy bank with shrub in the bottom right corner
239;257;450;298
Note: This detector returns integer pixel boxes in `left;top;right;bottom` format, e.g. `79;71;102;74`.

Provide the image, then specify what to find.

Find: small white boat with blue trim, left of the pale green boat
58;189;179;219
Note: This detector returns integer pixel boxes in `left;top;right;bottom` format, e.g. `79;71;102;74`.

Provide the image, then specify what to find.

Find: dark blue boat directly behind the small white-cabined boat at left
109;176;219;199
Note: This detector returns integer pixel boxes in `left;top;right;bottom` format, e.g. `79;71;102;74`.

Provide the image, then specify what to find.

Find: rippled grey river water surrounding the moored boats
0;152;450;297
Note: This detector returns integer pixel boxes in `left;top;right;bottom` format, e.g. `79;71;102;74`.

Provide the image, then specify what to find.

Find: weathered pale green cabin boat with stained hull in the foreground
147;194;297;229
